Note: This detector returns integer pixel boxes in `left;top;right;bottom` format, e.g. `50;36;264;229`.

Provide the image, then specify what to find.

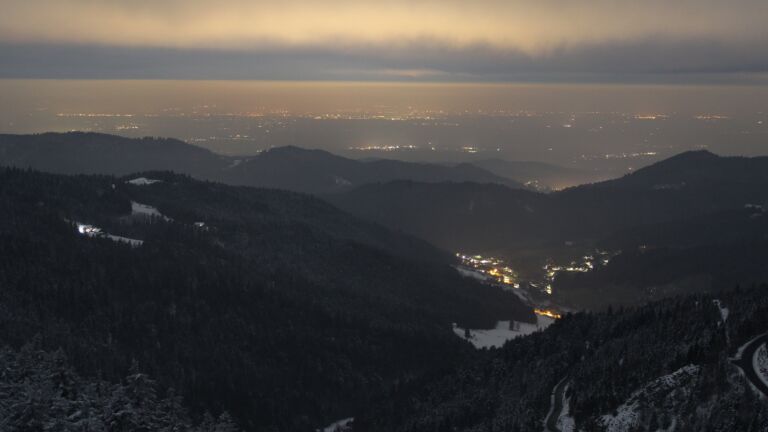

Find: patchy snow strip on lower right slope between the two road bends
600;365;699;432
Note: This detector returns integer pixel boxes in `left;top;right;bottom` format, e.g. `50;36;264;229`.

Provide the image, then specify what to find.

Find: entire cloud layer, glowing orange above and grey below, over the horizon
0;0;768;83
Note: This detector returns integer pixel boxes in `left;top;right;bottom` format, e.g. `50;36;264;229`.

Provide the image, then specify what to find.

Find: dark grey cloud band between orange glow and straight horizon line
0;38;768;82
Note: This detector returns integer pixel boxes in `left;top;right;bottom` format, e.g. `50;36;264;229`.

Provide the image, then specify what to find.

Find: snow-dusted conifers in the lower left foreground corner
0;339;240;432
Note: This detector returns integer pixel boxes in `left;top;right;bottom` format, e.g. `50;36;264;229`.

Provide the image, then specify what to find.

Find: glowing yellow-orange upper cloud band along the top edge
0;0;768;54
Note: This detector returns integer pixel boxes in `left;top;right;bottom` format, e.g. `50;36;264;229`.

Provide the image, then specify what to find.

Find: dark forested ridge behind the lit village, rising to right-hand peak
328;152;768;251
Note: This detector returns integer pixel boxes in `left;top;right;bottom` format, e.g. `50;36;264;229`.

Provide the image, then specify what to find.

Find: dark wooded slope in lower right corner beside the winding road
359;285;768;432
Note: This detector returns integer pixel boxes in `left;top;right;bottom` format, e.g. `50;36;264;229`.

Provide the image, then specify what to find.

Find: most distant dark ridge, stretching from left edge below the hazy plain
0;132;523;193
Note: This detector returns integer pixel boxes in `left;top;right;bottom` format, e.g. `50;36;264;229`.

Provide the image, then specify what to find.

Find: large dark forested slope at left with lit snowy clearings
0;169;533;431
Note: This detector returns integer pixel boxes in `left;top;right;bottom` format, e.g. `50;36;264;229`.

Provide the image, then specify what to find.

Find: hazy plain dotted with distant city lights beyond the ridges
6;81;768;187
